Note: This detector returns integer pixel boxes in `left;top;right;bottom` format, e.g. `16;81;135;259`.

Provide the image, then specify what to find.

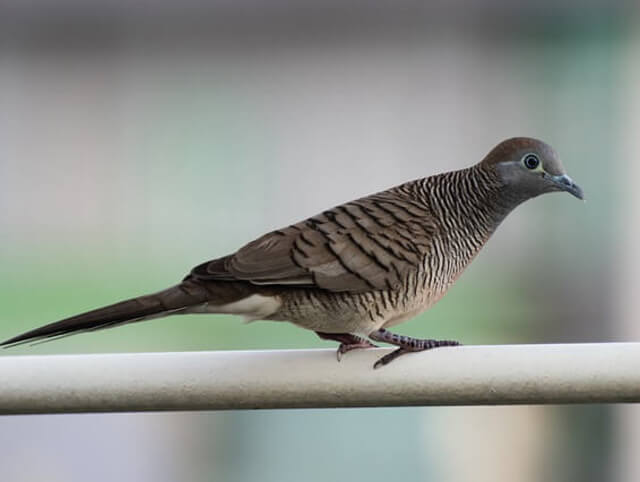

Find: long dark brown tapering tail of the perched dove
0;281;212;347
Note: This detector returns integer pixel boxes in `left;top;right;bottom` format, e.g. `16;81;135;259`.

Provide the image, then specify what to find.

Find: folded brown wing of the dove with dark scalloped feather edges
192;191;436;292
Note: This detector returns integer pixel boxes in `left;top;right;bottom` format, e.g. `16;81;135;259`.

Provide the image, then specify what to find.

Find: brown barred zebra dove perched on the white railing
0;137;584;368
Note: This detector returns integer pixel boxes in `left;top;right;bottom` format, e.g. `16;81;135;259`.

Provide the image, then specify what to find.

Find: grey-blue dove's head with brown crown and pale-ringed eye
480;137;584;200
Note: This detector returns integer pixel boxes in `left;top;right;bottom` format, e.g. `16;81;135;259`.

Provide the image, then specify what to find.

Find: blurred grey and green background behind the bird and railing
0;0;640;482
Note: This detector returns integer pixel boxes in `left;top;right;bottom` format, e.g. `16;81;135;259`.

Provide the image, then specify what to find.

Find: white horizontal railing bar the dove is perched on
0;343;640;414
